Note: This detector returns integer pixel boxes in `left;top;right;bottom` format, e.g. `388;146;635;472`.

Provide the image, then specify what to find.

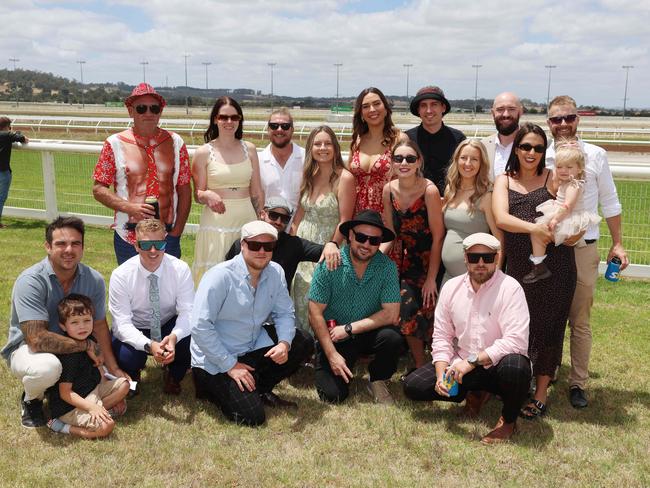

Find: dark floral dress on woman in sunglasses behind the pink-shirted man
390;192;434;342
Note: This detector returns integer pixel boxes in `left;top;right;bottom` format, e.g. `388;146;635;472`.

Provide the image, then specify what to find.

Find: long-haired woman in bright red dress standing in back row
348;87;406;215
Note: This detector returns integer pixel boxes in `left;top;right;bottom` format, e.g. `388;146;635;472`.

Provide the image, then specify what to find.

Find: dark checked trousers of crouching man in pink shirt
404;354;532;423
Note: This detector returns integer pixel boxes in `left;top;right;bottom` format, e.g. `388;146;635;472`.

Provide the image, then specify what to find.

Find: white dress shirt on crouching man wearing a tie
108;254;194;351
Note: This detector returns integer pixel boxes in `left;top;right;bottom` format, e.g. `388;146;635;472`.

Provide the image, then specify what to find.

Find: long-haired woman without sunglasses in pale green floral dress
291;125;355;333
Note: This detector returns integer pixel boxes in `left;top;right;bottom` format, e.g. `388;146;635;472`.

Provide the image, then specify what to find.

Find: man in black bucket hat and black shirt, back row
406;86;465;195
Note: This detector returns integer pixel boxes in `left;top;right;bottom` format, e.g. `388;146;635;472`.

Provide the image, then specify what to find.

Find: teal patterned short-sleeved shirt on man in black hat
309;246;400;324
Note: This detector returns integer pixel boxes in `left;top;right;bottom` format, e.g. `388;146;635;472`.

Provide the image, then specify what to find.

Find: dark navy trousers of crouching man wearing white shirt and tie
112;317;191;383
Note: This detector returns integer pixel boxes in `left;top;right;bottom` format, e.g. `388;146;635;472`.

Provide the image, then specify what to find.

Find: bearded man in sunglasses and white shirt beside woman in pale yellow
260;107;305;214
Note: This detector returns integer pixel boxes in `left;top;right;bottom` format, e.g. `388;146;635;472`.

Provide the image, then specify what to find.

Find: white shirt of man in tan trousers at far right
546;139;622;240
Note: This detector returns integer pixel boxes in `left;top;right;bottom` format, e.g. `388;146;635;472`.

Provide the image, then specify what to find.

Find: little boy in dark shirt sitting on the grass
47;293;129;439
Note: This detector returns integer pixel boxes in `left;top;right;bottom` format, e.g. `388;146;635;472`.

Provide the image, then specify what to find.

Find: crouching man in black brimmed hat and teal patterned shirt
309;210;404;404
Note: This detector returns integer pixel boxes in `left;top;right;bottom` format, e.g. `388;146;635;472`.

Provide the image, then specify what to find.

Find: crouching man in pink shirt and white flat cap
404;232;531;444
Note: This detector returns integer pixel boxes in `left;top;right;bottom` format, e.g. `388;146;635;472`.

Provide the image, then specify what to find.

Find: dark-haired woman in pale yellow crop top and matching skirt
192;96;264;286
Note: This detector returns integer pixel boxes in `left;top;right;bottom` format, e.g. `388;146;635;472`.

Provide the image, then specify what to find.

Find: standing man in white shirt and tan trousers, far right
546;95;630;408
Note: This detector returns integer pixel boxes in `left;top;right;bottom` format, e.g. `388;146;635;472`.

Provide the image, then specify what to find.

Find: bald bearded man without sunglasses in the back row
481;92;524;181
